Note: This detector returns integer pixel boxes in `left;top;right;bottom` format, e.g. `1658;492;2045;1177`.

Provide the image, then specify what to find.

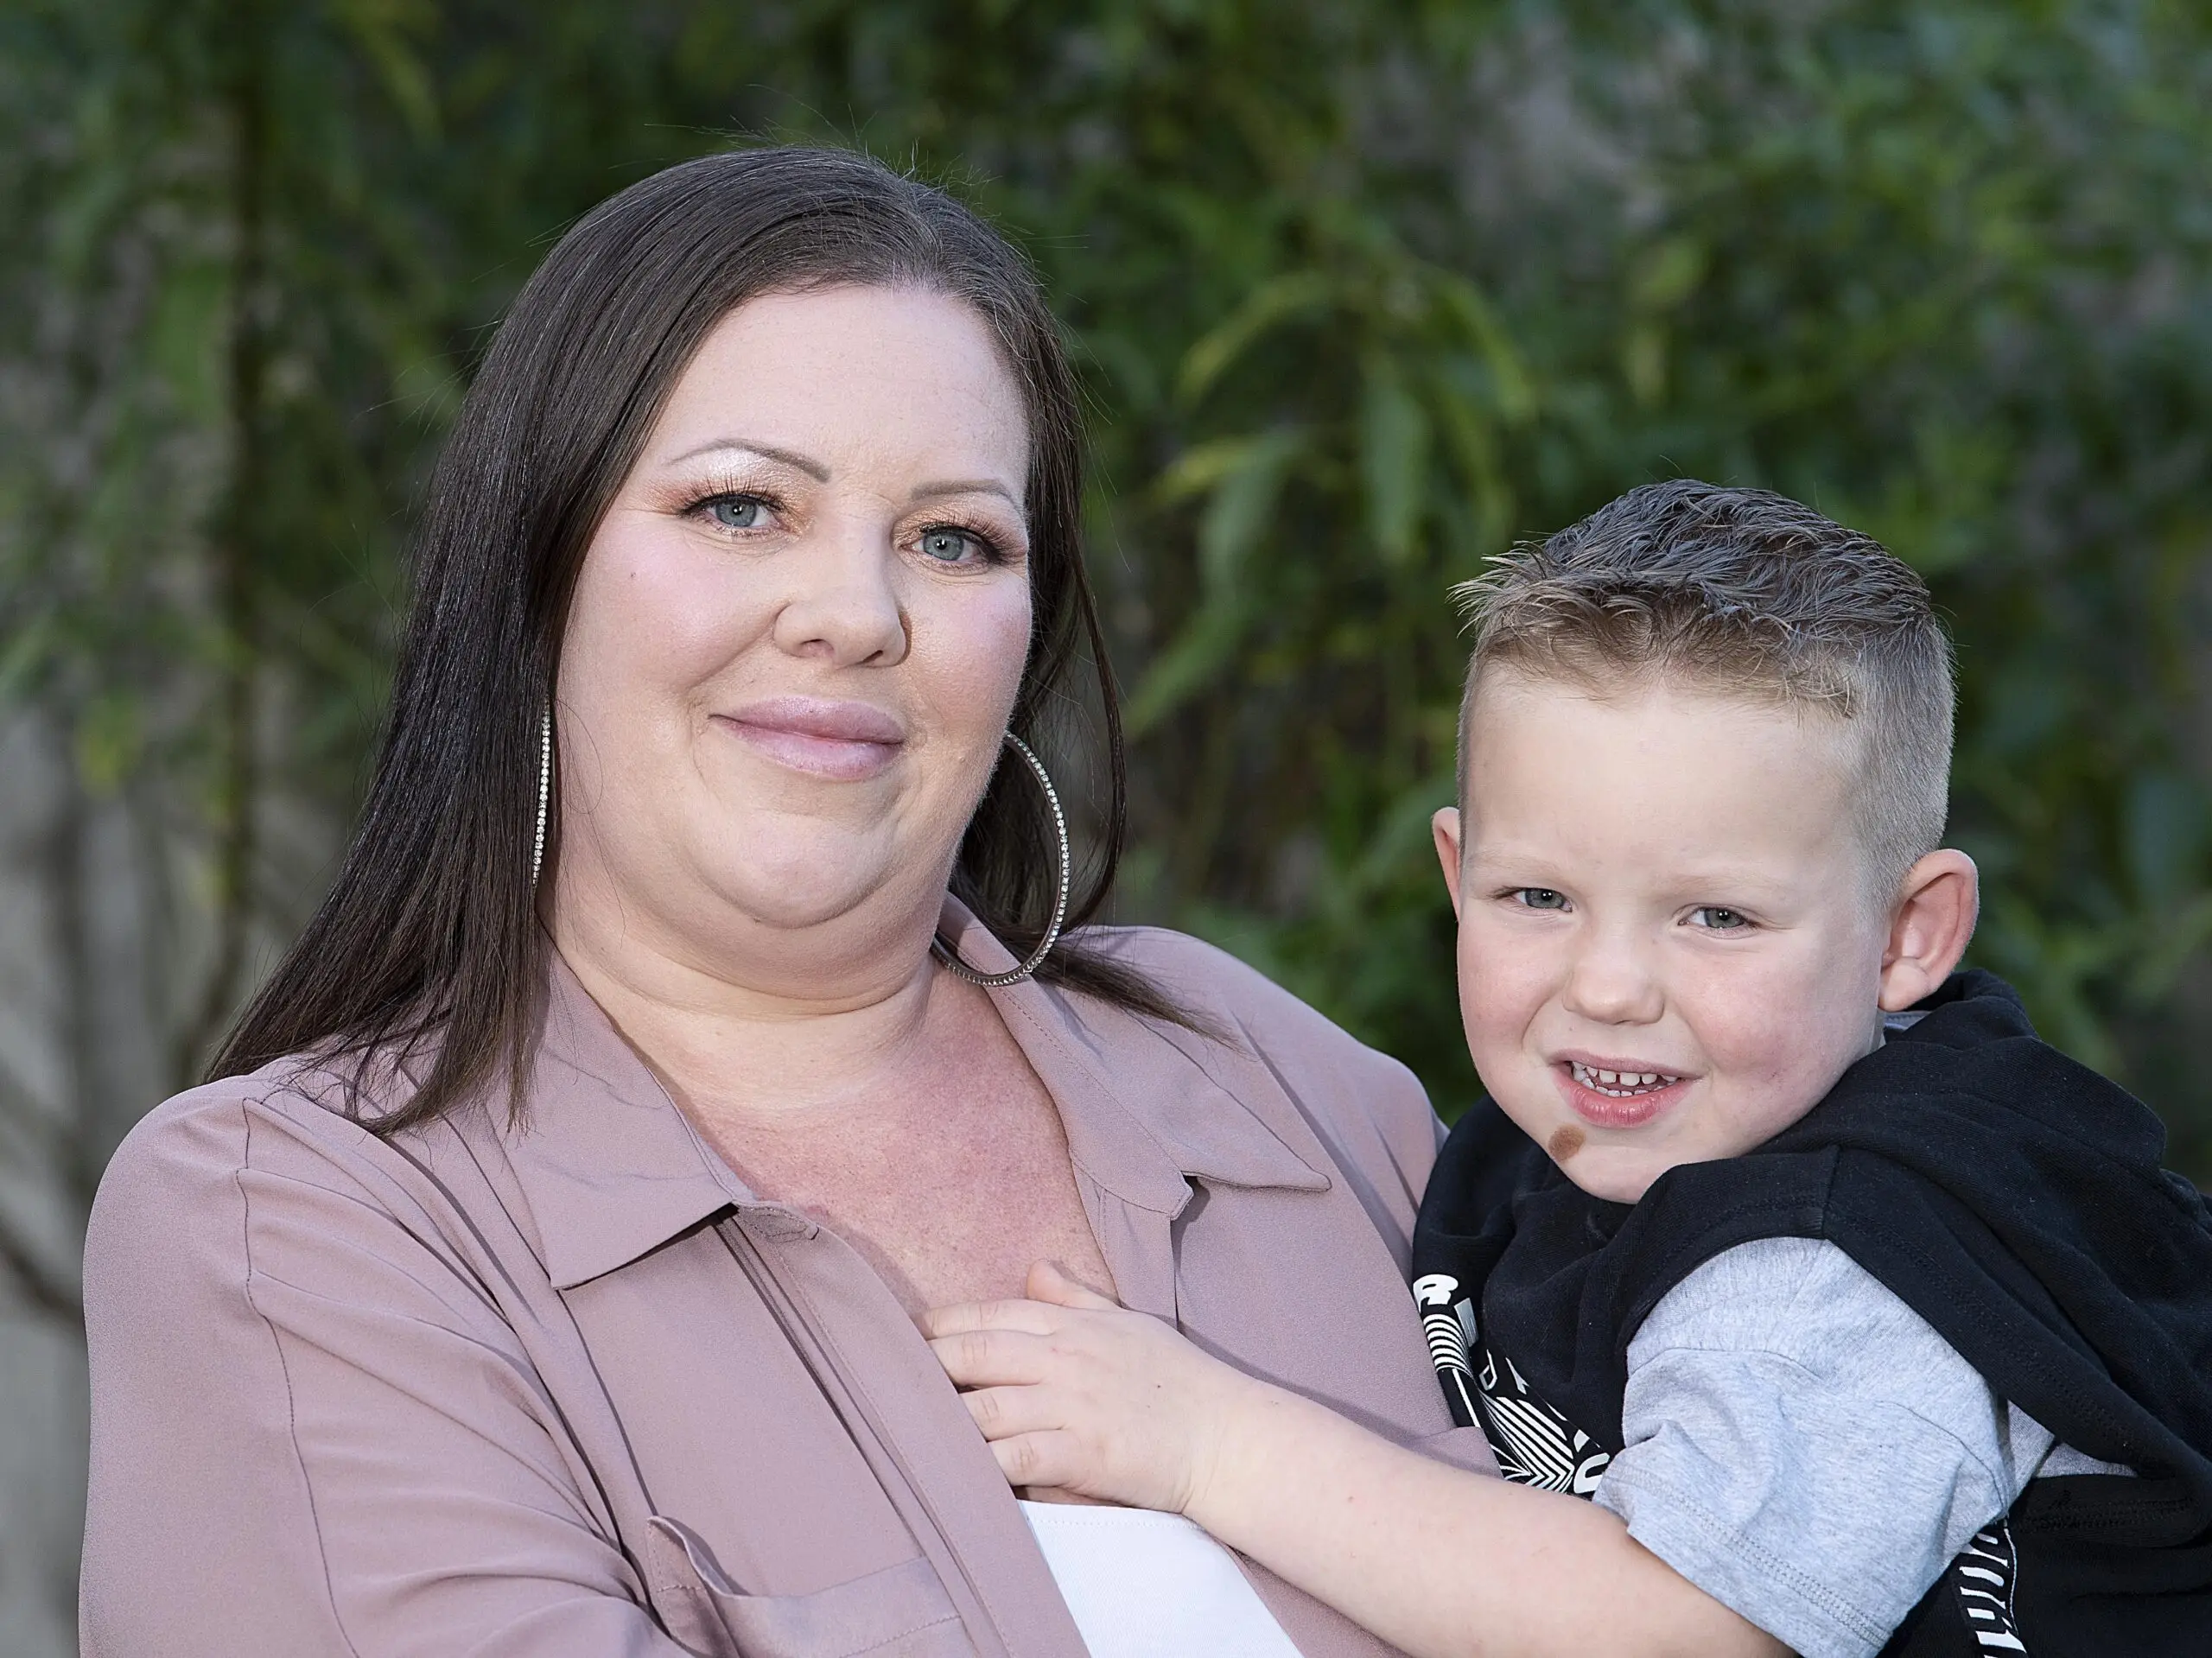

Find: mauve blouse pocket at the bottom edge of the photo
646;1515;976;1658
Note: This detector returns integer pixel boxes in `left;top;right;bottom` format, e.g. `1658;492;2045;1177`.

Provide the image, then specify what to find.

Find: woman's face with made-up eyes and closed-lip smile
556;288;1031;986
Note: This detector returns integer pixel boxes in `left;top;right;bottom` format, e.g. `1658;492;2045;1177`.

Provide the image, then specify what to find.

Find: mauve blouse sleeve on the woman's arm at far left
82;1083;681;1658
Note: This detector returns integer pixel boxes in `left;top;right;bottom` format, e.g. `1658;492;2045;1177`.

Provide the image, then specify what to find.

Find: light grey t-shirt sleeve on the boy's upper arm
1597;1238;2050;1658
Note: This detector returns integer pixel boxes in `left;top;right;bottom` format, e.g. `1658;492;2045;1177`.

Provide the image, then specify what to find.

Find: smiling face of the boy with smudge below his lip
1438;670;1889;1203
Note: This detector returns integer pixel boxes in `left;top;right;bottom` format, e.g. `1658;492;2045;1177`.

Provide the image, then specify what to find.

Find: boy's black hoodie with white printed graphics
1414;973;2212;1658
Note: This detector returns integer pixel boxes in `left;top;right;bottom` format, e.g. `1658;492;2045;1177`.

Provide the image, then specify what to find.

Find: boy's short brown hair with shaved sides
1453;478;1955;899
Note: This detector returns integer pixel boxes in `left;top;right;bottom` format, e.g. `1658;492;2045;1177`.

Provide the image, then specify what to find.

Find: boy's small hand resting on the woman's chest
920;1262;1261;1515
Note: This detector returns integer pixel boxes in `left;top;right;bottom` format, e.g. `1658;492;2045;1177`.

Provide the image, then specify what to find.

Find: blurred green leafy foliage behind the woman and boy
0;0;2212;1178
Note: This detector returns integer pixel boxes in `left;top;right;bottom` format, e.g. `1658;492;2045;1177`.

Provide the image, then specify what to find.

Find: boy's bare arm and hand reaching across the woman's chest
923;1267;1785;1658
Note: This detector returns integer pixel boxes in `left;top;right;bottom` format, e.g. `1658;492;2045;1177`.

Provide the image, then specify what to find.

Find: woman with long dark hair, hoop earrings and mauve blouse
84;150;1484;1658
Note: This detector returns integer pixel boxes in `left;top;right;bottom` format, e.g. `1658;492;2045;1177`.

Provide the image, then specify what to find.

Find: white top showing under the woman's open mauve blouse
1022;1503;1299;1658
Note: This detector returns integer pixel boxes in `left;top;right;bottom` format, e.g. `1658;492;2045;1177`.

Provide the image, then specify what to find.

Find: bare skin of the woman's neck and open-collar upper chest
539;857;1113;1313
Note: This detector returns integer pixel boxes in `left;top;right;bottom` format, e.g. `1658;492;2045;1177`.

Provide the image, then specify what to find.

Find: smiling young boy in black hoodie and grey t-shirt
929;482;2212;1658
